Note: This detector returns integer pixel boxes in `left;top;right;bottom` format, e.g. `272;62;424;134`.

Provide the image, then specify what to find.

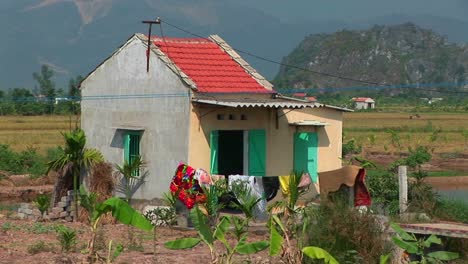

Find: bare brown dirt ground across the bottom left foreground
0;216;278;264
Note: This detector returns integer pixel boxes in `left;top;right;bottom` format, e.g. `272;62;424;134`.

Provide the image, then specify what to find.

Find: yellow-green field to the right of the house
343;112;468;157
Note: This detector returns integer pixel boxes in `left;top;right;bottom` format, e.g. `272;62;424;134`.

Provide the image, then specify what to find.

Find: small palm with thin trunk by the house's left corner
47;129;104;221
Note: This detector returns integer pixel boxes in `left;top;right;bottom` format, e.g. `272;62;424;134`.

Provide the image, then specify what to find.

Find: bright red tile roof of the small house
152;37;274;93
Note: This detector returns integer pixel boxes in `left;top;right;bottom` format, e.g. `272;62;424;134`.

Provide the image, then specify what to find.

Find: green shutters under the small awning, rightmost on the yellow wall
293;132;318;182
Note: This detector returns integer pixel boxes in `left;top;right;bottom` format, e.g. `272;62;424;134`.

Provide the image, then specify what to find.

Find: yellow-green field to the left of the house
0;115;79;154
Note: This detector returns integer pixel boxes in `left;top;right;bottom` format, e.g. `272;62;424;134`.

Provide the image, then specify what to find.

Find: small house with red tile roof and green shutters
81;34;350;200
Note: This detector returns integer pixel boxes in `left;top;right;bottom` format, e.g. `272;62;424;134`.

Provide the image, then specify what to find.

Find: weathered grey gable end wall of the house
81;38;190;199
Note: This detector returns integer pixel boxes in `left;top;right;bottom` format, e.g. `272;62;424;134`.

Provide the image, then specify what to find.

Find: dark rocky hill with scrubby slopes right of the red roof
275;23;468;93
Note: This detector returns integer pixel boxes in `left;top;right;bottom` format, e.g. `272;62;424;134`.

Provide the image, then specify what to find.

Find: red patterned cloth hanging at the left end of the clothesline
169;163;206;209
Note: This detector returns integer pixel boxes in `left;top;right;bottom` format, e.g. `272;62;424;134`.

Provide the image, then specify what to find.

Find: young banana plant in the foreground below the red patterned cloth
164;206;269;264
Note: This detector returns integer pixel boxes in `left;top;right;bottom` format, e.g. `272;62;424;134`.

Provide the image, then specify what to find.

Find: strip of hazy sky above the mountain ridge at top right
239;0;468;21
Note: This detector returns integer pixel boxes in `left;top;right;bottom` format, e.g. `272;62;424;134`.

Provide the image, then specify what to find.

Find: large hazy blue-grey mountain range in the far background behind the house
0;0;468;89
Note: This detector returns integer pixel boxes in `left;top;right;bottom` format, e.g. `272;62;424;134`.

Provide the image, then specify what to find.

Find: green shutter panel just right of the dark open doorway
249;129;266;176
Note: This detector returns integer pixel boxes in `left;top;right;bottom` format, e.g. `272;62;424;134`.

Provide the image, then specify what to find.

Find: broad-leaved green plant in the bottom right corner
390;223;459;263
